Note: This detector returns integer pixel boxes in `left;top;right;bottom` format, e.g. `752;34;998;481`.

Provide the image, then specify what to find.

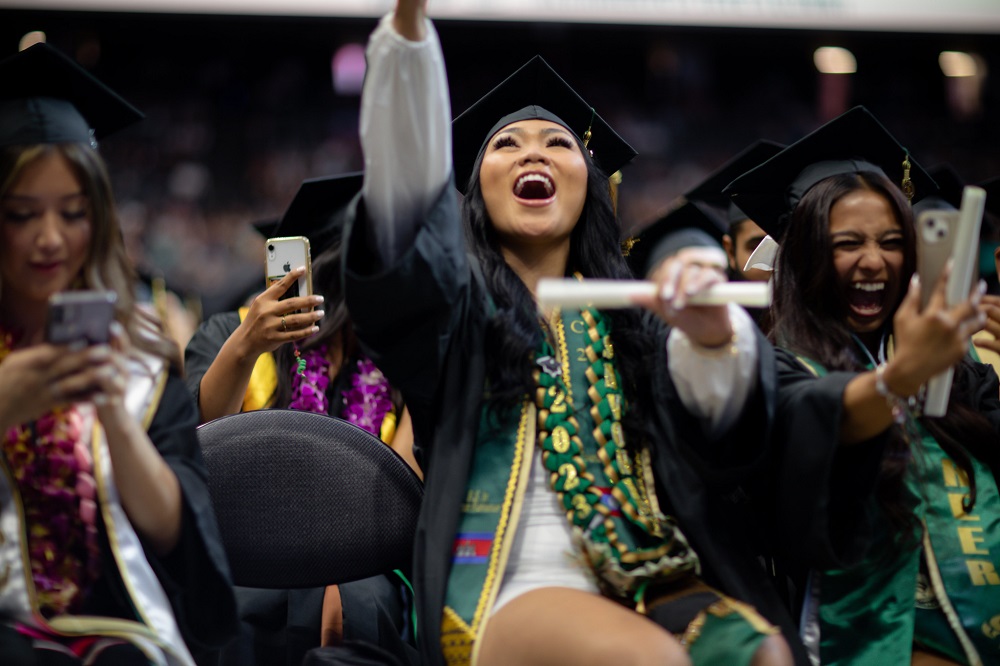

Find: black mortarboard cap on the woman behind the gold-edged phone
274;171;363;256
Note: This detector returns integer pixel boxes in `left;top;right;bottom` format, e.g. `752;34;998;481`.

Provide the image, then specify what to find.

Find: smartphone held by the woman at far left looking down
45;291;118;345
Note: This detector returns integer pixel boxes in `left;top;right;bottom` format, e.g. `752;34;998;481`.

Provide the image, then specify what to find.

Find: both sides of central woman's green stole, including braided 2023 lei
441;309;699;664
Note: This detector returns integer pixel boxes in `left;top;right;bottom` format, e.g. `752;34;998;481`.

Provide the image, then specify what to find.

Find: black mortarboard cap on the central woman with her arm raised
451;56;636;194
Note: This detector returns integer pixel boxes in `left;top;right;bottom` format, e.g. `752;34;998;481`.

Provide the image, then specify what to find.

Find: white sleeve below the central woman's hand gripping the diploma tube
667;304;758;435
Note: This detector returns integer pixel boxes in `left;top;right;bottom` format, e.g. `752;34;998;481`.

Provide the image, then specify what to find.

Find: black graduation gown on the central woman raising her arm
345;182;880;664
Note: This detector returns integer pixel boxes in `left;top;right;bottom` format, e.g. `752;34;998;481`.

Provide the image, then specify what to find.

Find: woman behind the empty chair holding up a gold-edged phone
185;173;420;666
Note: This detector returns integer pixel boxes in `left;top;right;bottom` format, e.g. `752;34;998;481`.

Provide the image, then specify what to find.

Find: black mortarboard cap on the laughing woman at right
724;106;937;241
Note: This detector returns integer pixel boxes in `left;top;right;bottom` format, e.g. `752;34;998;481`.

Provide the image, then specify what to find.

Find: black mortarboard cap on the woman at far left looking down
0;43;143;146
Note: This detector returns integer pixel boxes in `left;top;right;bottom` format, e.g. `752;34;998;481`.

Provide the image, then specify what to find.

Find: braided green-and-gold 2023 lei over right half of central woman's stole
534;308;698;604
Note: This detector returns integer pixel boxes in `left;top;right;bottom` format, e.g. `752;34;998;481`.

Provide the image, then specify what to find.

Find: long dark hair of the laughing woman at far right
770;173;1000;543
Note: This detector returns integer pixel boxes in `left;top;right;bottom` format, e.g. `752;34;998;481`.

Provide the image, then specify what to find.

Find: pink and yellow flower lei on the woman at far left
0;324;100;616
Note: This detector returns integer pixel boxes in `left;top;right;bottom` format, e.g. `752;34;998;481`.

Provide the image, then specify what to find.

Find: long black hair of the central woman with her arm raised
462;130;653;441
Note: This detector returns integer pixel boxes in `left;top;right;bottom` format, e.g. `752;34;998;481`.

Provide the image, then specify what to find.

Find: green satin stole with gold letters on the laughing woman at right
800;357;1000;666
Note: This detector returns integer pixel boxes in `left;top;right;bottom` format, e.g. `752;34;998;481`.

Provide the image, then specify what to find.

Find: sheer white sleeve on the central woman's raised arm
361;14;452;263
